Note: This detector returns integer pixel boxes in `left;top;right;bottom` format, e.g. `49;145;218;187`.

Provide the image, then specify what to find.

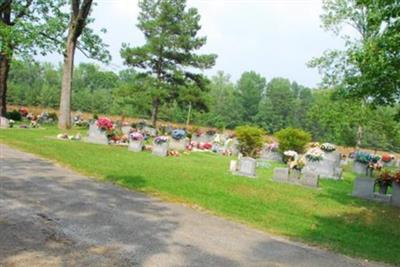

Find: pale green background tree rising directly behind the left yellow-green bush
237;71;266;123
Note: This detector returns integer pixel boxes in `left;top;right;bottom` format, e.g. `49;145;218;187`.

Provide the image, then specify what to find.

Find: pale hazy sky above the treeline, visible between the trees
46;0;344;87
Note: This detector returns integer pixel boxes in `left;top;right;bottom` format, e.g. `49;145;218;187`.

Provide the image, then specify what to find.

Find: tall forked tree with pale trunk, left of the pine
58;0;110;129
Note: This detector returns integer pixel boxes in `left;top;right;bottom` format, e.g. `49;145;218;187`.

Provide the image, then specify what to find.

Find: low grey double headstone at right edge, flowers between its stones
353;177;400;207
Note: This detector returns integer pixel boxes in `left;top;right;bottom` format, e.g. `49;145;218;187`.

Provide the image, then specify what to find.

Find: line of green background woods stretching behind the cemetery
8;61;400;152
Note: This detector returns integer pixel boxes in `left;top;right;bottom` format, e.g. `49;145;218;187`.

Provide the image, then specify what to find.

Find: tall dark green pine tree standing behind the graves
121;0;216;127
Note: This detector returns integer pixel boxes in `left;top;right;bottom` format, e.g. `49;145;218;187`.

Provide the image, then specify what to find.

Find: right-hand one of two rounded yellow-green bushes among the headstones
275;128;311;153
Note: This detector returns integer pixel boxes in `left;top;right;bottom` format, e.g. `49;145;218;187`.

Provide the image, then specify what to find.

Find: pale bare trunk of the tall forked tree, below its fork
58;34;76;129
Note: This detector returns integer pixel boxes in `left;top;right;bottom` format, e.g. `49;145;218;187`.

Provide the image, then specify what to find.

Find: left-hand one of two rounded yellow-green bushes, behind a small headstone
236;126;265;157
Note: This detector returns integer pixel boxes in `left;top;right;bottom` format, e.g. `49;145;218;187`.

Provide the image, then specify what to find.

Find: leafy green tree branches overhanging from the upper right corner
310;0;400;108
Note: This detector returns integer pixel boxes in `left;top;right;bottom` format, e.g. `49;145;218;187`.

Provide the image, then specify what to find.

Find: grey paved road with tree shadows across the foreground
0;145;390;267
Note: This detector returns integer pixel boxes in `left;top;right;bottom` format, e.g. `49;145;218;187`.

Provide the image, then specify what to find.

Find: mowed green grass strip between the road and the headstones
0;128;400;265
